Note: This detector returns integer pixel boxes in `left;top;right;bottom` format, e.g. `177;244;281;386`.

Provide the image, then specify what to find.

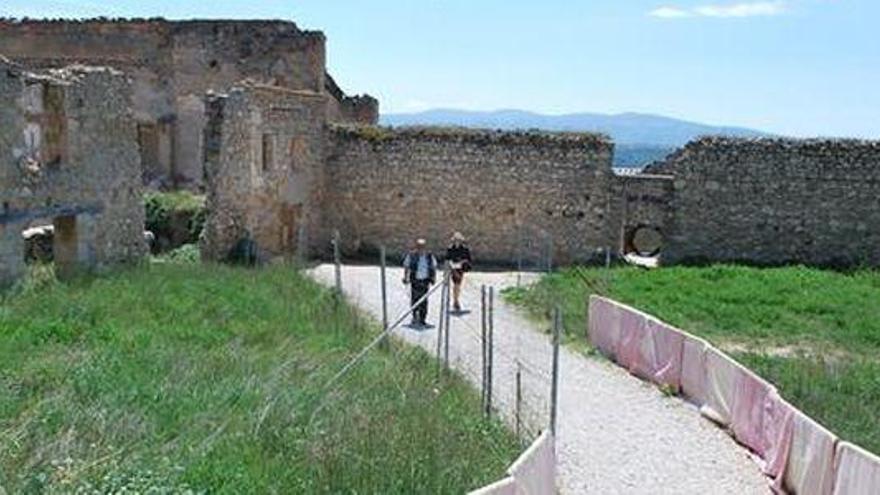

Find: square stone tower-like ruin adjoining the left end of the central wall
201;84;327;260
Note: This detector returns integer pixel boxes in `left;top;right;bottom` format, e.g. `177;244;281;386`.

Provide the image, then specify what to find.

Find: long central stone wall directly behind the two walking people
317;127;616;263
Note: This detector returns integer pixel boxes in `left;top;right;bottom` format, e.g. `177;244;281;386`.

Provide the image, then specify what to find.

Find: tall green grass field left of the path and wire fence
0;262;519;494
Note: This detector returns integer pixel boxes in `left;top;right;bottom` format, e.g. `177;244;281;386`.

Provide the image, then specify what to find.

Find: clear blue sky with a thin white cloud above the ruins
0;0;880;139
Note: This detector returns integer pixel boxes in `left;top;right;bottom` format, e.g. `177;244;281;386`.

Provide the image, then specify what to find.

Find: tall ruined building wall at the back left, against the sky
0;19;378;188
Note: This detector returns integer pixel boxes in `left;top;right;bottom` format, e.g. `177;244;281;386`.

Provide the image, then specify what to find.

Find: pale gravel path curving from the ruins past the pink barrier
311;265;770;495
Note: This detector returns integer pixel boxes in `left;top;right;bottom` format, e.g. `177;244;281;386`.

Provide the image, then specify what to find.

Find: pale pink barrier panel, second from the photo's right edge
785;409;837;495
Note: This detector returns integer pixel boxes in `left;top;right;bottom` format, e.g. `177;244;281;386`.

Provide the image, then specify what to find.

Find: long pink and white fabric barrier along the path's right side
588;296;880;495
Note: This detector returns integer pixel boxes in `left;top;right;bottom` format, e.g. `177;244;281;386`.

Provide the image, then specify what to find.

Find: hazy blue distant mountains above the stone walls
380;109;768;166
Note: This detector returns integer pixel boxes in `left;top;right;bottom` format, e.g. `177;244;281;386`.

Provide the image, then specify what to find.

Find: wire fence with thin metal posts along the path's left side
326;230;562;454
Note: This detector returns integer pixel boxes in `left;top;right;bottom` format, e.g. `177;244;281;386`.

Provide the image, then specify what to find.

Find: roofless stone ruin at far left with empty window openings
0;58;145;284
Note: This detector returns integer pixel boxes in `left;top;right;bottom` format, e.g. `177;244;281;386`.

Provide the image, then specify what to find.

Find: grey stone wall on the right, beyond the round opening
657;138;880;266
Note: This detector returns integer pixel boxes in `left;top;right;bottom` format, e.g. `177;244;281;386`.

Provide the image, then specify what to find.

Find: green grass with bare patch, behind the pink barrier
505;265;880;452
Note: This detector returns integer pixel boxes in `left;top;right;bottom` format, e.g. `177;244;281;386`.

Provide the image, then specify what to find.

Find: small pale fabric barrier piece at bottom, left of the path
468;431;556;495
